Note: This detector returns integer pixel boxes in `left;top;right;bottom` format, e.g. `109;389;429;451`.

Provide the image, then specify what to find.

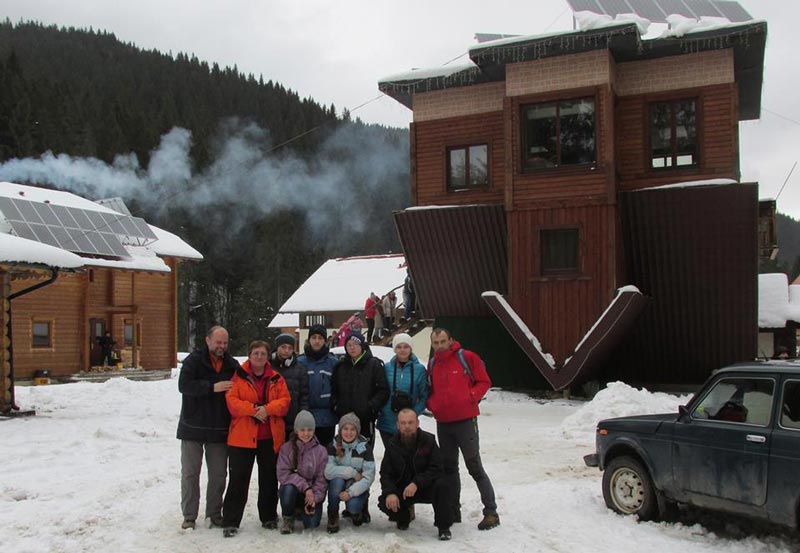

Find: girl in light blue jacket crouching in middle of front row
325;413;375;534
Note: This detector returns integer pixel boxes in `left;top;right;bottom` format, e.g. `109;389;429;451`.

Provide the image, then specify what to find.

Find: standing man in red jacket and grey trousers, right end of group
428;328;500;530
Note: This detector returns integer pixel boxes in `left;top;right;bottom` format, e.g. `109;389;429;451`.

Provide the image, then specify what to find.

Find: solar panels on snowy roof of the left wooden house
0;197;157;257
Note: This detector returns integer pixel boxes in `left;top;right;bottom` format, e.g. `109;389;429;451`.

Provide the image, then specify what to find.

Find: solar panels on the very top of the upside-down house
567;0;753;23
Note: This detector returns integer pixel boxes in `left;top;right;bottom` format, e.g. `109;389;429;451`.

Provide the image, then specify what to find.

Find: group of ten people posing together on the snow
177;325;500;540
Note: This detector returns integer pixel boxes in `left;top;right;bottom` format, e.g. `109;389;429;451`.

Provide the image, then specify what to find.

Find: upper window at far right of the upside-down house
650;99;698;169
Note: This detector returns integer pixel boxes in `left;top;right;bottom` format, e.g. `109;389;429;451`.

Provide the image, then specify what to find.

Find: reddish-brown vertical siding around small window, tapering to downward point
508;205;617;363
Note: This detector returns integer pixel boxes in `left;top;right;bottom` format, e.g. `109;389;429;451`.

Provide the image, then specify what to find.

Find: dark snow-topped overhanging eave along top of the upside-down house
378;12;767;120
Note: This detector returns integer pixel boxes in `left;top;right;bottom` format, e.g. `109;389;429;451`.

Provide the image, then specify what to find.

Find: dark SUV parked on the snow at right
584;361;800;528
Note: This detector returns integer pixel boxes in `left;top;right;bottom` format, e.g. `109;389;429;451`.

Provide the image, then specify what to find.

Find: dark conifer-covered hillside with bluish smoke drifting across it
0;20;409;352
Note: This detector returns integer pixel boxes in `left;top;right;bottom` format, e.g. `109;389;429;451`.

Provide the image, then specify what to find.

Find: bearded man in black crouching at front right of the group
378;408;455;540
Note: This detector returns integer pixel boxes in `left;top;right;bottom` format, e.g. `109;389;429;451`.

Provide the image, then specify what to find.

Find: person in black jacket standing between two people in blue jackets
331;333;389;448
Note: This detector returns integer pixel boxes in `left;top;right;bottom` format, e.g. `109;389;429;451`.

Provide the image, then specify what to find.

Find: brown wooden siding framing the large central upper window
506;85;614;209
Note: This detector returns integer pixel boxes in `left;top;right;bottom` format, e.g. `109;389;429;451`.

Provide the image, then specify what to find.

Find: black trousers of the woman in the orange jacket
222;440;278;528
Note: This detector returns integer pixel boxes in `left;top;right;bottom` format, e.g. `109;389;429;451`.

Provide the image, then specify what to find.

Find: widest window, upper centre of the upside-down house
522;98;596;170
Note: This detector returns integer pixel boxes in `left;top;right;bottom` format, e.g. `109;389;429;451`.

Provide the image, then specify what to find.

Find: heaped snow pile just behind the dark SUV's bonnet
560;382;692;444
